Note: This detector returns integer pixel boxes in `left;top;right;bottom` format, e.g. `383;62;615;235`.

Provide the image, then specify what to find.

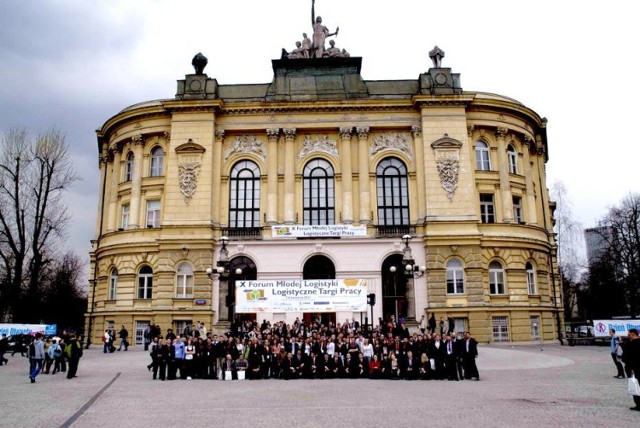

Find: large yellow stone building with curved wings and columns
87;37;562;343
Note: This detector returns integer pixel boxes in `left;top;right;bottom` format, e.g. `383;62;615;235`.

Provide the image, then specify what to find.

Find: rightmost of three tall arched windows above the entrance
376;158;409;226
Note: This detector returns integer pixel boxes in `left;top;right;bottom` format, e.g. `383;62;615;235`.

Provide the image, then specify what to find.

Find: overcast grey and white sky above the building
0;0;640;268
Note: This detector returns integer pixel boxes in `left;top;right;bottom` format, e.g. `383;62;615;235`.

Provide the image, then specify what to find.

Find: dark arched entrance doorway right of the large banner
380;254;408;322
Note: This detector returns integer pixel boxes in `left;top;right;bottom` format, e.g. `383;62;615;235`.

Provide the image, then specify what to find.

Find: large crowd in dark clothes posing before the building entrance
145;318;480;381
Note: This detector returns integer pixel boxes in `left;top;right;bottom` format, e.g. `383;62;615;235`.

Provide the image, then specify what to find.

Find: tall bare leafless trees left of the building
0;130;78;321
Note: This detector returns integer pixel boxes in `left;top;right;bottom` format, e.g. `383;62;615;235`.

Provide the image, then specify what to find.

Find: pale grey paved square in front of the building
0;344;640;428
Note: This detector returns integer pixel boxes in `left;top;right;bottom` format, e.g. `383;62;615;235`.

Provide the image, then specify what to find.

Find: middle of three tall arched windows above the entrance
303;159;335;225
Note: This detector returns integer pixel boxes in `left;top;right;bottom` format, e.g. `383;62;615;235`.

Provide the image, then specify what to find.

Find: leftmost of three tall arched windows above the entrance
229;160;260;227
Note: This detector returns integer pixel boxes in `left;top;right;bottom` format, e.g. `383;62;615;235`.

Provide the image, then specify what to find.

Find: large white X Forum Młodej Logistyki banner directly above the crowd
236;279;367;313
